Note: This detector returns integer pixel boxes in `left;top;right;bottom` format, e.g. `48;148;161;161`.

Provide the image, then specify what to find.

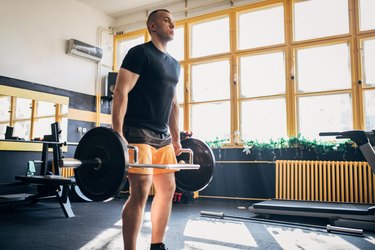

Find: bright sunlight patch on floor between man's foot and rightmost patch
184;219;257;249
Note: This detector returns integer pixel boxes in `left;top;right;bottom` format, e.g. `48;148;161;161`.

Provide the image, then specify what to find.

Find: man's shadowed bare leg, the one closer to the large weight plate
122;173;152;250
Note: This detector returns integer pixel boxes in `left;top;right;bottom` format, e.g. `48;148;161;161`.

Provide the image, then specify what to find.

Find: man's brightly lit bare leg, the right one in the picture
151;172;176;243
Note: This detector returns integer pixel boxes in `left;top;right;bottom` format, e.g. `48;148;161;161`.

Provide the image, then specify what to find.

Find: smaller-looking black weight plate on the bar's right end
175;138;215;192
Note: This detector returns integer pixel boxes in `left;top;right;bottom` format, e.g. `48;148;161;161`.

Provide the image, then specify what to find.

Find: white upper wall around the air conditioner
0;0;114;95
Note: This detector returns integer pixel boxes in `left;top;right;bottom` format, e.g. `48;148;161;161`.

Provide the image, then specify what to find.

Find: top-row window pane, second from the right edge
293;0;349;41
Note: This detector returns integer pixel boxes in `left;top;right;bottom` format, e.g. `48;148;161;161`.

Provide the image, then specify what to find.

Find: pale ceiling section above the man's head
78;0;181;18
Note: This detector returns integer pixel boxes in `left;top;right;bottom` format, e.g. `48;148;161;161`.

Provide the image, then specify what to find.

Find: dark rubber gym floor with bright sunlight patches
0;197;375;250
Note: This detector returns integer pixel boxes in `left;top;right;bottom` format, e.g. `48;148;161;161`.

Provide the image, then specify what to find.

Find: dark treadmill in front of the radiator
249;130;375;230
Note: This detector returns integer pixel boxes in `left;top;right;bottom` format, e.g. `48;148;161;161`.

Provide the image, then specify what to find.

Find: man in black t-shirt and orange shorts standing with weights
112;9;181;250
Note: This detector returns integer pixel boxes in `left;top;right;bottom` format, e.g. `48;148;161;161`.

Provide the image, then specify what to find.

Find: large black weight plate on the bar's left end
74;127;129;201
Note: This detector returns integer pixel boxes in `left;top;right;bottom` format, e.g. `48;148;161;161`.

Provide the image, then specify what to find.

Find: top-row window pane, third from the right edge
238;6;284;49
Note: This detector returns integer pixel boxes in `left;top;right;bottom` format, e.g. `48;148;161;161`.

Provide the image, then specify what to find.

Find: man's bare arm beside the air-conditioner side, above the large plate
112;68;139;137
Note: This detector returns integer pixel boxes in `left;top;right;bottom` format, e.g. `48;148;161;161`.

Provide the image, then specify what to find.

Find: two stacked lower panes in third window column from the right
239;51;287;141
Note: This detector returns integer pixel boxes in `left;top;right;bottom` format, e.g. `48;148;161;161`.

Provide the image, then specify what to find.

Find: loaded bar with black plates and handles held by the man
59;127;215;201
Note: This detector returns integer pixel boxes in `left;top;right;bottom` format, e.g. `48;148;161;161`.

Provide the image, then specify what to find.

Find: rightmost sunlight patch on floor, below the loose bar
266;226;359;250
